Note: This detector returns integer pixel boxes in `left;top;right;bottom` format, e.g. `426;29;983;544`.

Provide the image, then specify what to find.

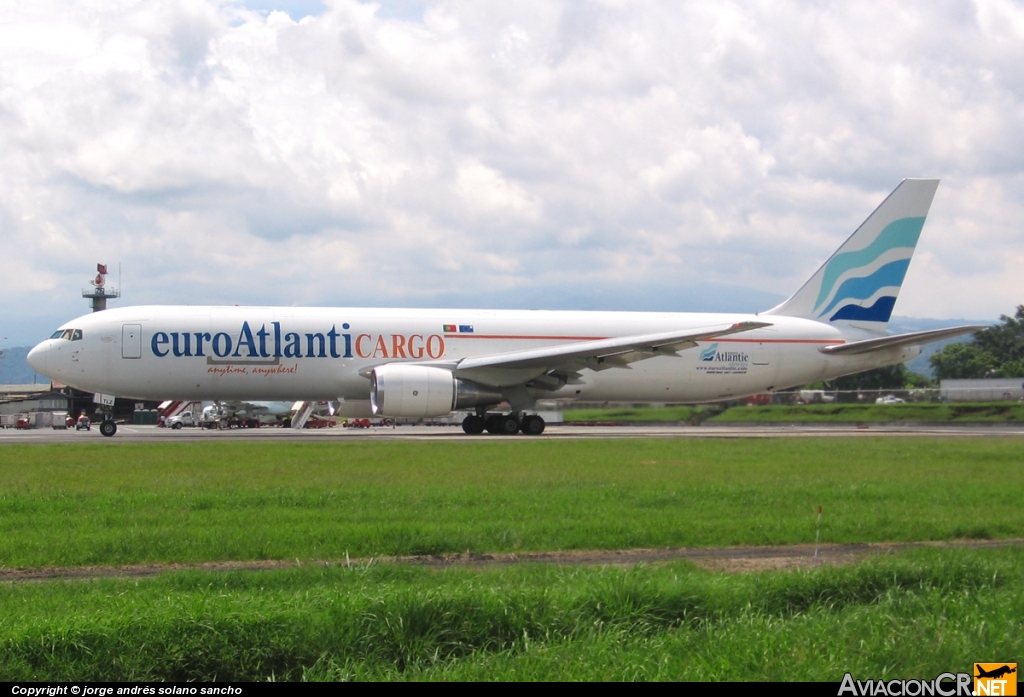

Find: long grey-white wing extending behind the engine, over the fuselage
455;321;771;387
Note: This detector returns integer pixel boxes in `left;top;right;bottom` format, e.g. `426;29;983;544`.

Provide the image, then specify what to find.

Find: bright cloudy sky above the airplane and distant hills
0;0;1024;348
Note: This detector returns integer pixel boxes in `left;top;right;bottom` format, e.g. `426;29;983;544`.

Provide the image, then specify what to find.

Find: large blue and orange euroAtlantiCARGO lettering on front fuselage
150;321;444;359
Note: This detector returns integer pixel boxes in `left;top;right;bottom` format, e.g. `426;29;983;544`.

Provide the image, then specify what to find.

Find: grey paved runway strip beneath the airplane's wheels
0;423;1024;445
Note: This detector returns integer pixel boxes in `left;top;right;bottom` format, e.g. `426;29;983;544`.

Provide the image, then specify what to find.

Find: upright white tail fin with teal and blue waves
763;179;939;332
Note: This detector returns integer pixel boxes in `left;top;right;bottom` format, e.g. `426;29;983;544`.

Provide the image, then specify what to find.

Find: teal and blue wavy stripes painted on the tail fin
814;217;925;322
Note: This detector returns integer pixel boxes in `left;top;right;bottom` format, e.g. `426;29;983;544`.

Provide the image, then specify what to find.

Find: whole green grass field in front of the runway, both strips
0;438;1024;681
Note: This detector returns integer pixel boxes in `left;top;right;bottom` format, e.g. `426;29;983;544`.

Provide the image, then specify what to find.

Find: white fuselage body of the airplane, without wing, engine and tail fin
30;306;920;403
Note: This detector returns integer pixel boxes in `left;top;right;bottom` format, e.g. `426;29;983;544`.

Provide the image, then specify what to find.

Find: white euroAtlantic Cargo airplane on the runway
29;179;982;436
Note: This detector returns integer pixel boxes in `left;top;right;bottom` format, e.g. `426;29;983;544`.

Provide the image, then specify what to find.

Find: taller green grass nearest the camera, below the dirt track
0;549;1024;682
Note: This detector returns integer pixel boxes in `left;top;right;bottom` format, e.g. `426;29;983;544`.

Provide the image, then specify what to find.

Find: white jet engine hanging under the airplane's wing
370;363;503;418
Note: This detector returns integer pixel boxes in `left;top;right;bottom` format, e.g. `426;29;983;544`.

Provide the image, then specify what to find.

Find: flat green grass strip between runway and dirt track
0;438;1024;568
